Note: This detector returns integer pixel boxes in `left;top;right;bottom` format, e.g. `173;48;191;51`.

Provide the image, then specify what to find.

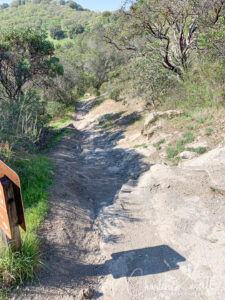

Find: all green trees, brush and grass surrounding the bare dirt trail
0;0;225;296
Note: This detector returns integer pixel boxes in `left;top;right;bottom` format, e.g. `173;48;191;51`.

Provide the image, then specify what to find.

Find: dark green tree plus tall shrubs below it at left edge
0;29;63;149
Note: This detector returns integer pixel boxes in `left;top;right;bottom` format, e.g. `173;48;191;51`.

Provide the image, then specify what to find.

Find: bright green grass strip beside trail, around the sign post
0;154;54;299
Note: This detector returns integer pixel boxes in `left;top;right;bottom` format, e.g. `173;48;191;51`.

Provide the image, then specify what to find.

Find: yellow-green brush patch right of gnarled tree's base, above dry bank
160;57;225;110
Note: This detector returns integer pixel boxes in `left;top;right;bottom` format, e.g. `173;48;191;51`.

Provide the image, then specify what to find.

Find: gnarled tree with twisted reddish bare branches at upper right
105;0;225;77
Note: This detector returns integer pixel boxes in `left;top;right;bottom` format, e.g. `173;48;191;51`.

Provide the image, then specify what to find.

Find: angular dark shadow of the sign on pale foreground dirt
73;245;186;279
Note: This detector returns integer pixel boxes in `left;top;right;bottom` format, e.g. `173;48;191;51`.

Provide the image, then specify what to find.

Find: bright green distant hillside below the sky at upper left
0;1;100;39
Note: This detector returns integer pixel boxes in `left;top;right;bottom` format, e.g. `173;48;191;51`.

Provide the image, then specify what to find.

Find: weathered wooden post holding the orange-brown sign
0;177;22;251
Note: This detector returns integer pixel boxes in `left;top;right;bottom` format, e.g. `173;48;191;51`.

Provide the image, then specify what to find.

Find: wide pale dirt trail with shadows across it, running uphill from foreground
13;98;225;300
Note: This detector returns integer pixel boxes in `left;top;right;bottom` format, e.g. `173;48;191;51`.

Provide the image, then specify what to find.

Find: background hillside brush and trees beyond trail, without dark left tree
0;0;225;117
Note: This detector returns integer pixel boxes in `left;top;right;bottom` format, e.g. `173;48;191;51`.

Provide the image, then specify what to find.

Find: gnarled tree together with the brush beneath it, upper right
104;0;225;106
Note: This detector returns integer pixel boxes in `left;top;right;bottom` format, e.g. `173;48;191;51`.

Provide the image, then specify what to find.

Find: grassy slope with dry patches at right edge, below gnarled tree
162;60;225;165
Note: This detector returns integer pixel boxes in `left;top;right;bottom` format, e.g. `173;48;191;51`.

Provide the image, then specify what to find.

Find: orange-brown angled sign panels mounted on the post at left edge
0;160;26;238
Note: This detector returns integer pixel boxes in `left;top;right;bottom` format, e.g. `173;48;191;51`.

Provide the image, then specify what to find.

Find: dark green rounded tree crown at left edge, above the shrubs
0;28;63;104
